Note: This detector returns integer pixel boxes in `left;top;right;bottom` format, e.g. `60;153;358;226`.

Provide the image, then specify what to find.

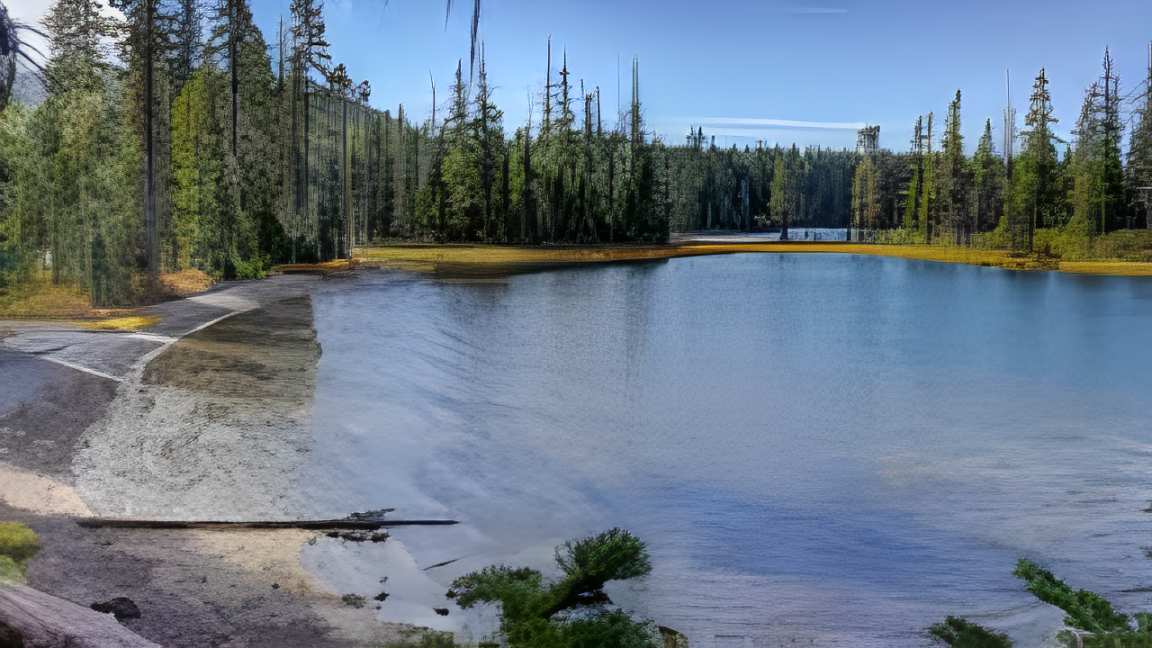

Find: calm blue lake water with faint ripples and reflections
292;254;1152;648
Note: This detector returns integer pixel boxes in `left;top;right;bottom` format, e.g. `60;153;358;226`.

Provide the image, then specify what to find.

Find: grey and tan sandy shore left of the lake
0;276;416;648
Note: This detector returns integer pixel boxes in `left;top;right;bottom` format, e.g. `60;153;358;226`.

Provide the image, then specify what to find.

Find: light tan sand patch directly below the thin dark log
188;529;323;594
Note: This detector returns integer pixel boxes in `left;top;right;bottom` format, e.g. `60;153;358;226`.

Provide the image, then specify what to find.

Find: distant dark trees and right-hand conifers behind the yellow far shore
672;51;1152;247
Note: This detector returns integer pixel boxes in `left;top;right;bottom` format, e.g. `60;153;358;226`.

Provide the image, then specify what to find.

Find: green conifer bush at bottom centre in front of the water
448;529;662;648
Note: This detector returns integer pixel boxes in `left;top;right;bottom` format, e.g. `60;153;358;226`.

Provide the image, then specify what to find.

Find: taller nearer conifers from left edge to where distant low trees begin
0;0;669;304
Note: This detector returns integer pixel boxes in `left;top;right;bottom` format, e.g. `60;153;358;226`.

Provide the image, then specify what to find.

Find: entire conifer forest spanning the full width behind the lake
0;0;1152;306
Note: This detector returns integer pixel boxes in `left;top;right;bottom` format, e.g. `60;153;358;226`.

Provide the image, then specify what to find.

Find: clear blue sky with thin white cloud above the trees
6;0;1152;151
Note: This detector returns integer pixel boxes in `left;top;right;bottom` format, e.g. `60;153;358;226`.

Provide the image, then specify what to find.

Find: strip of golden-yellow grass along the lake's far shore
331;241;1152;277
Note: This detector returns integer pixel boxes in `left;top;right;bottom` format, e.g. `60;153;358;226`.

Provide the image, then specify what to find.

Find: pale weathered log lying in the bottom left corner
0;580;160;648
